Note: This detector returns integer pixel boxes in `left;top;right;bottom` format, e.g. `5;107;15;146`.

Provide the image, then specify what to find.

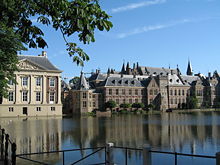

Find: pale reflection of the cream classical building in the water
1;117;62;164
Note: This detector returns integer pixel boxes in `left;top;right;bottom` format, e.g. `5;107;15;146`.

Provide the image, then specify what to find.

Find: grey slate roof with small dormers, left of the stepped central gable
104;77;144;87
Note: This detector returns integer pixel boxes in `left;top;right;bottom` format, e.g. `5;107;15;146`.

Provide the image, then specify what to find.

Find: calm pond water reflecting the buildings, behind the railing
0;112;220;165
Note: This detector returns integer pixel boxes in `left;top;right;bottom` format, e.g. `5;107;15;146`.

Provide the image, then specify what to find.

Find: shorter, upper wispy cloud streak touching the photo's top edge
111;0;167;13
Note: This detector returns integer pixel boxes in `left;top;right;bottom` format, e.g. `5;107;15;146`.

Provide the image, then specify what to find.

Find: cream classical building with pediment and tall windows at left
0;51;62;117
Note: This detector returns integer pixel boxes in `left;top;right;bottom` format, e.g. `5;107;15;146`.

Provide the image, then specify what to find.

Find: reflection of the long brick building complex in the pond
65;112;220;154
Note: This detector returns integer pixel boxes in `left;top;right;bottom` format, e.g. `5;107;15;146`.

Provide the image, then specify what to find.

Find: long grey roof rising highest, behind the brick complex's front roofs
139;66;177;76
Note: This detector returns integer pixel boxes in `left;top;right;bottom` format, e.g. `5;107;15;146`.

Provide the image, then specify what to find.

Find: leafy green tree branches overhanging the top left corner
0;0;112;96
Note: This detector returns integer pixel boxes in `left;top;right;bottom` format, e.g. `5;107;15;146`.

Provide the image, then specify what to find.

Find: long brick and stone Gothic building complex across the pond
70;62;220;113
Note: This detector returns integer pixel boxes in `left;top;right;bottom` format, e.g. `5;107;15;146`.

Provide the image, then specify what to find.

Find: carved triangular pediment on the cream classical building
17;59;45;70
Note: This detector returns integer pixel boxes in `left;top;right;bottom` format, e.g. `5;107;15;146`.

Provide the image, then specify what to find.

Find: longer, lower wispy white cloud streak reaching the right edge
116;17;220;39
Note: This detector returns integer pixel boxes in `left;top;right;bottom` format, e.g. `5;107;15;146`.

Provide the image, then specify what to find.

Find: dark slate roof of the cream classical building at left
18;55;61;71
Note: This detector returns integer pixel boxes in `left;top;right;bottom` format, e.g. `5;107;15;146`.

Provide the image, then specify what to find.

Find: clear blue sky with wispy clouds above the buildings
21;0;220;79
